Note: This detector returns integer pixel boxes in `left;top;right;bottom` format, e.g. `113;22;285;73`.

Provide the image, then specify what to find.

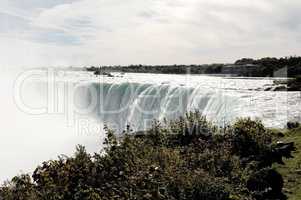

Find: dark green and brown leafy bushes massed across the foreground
0;112;299;200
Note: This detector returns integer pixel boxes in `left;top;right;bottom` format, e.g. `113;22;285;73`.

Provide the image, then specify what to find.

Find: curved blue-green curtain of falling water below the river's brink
77;82;241;132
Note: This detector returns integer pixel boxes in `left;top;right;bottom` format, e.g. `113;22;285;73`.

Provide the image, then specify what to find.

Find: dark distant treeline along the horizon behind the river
87;57;301;77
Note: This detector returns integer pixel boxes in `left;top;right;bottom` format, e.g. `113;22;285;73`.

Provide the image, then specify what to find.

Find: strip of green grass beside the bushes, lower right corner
274;127;301;200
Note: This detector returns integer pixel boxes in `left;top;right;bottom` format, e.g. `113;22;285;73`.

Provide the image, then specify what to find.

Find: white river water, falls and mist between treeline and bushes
0;69;301;182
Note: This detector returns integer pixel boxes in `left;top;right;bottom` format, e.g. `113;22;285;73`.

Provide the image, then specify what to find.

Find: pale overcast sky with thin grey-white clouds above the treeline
0;0;301;67
